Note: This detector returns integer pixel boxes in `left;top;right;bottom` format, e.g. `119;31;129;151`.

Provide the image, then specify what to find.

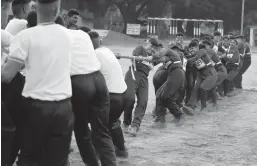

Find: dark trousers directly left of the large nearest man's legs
2;73;26;165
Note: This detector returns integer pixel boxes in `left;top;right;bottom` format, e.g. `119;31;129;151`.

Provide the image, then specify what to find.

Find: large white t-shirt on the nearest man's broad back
9;24;72;101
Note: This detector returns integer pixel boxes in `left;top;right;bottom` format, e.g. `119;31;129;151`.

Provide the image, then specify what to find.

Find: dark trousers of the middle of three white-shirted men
71;71;116;166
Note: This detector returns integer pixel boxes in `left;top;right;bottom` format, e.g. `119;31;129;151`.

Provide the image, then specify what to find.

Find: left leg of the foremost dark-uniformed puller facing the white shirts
123;70;136;126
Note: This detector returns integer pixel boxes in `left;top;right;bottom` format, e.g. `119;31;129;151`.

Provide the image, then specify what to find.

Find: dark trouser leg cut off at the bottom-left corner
1;102;15;166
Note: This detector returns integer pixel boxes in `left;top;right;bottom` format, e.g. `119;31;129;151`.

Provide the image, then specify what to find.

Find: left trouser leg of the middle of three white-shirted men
71;75;98;166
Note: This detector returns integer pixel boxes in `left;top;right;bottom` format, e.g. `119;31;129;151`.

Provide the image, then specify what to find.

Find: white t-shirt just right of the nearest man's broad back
68;29;101;75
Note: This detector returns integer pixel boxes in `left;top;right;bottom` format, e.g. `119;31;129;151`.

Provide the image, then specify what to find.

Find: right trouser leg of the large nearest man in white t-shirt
38;100;74;166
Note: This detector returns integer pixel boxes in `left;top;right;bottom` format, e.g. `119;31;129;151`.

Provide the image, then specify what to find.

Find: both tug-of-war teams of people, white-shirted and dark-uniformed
1;0;251;166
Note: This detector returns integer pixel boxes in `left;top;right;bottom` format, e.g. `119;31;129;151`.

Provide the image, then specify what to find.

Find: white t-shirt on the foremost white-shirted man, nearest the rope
95;47;127;93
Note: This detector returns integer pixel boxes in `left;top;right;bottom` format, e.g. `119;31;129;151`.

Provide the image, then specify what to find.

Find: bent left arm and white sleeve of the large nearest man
1;31;29;82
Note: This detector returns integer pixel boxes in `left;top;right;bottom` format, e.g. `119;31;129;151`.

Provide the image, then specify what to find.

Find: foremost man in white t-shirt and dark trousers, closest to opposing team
88;31;128;158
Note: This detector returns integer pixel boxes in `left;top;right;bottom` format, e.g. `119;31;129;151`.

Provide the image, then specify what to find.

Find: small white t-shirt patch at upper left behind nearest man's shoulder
5;18;28;36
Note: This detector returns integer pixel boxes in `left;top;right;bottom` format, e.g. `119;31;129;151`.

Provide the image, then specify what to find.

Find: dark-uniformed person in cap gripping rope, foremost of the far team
123;38;159;136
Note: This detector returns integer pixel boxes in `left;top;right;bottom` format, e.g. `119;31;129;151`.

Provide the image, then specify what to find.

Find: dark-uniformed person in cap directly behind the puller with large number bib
202;40;227;107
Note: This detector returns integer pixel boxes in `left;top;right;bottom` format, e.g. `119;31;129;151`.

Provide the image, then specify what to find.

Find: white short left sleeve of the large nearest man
9;32;30;63
